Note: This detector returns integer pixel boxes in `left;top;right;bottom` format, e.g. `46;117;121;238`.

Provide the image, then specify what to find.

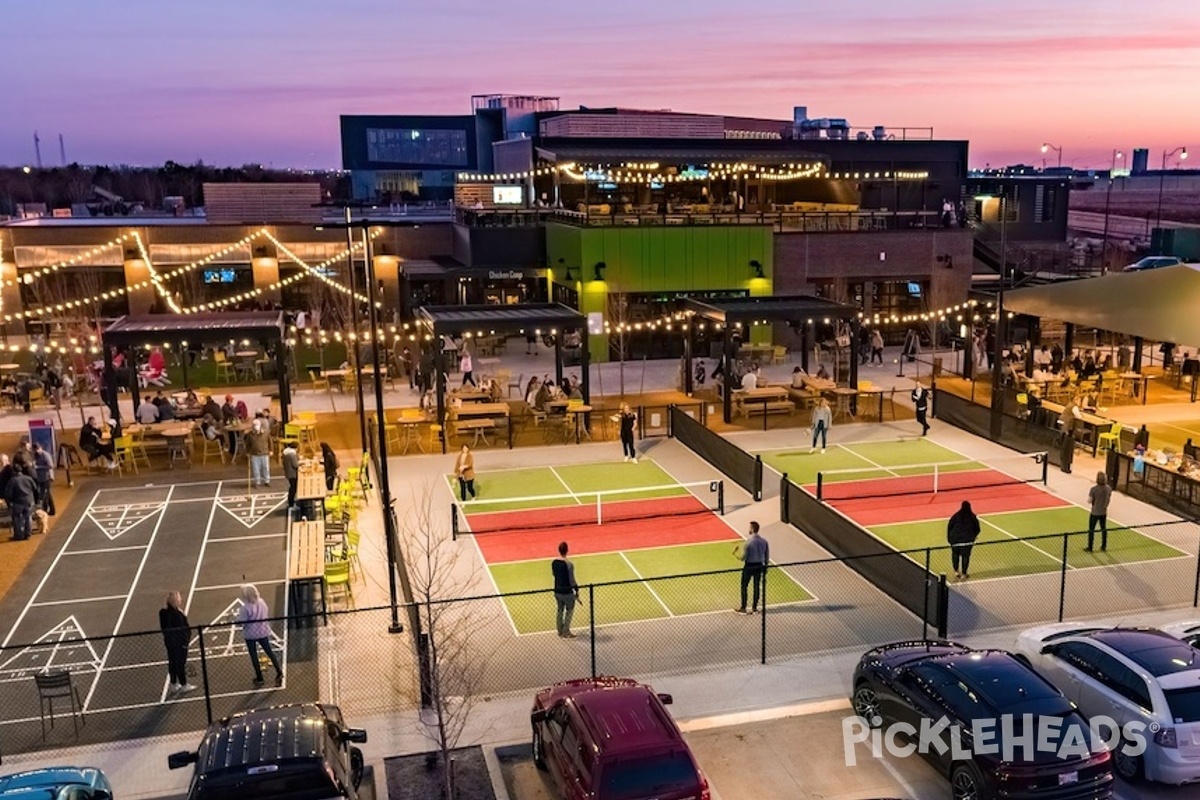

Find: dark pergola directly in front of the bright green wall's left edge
416;303;592;452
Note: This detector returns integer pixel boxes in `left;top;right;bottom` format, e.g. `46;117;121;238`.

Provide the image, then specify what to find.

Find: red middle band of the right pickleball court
829;483;1070;528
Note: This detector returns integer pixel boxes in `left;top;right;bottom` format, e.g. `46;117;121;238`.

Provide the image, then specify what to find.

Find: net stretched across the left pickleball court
450;480;725;537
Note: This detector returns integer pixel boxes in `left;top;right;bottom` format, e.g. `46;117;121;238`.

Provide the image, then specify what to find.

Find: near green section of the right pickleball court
870;506;1183;578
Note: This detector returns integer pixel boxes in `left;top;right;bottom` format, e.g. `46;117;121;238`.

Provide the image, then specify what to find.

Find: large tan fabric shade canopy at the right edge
1004;264;1200;345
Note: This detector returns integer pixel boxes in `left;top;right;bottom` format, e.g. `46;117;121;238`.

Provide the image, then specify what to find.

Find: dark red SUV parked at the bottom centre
529;678;712;800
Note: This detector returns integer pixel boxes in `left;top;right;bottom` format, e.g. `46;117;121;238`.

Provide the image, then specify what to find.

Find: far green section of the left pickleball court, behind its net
446;459;688;513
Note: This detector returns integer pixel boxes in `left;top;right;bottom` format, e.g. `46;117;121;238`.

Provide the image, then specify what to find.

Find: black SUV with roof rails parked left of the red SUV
167;703;367;800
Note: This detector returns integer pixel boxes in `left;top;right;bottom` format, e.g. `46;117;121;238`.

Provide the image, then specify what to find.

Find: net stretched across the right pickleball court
816;452;1050;503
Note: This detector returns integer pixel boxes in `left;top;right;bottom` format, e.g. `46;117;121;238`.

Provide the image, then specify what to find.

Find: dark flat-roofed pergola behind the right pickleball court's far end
682;295;858;422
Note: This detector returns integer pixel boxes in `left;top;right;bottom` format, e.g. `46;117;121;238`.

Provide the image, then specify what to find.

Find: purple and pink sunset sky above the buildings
0;0;1200;168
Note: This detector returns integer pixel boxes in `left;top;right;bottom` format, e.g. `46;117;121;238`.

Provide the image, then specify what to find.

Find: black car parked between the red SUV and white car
851;640;1112;800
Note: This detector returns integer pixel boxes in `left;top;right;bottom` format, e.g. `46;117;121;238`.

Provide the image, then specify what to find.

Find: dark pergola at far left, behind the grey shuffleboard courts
101;311;292;422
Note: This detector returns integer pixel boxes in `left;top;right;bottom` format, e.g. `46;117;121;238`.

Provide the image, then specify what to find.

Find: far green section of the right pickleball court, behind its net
758;439;1003;486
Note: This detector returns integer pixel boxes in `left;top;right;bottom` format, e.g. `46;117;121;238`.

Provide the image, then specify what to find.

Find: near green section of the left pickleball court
488;542;814;633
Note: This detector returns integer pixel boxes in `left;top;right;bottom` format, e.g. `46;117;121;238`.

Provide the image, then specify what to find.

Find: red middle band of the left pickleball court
467;510;738;564
